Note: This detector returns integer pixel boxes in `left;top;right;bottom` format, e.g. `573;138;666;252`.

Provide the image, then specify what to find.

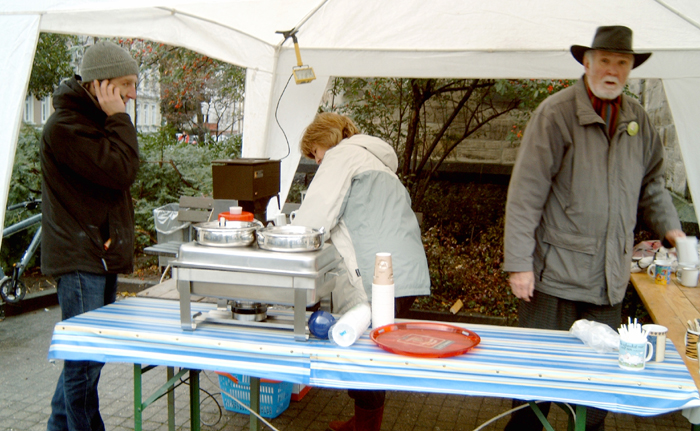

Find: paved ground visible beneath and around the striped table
0;296;691;431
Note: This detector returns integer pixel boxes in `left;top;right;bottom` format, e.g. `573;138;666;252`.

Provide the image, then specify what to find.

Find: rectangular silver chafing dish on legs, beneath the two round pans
172;242;342;341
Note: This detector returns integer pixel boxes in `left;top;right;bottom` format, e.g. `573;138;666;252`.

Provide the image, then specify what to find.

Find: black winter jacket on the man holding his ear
41;76;139;276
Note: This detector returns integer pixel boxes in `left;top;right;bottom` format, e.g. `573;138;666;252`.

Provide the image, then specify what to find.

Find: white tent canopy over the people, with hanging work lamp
0;0;700;245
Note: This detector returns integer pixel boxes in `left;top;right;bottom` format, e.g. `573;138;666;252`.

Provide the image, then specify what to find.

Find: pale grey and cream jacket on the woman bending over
293;135;430;313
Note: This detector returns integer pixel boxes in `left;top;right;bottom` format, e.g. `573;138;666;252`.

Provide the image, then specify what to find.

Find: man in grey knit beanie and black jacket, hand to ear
40;41;139;431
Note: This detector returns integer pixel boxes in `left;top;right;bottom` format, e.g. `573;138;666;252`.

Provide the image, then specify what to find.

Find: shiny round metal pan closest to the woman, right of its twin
256;225;323;252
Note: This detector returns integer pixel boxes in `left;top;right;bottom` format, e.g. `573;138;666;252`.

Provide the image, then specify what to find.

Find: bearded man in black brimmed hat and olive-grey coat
504;26;685;431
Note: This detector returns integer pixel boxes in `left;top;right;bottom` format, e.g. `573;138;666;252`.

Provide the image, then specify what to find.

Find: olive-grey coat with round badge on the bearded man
504;78;680;305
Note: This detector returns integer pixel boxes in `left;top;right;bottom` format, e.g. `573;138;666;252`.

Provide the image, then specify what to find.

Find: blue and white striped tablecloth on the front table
49;298;700;416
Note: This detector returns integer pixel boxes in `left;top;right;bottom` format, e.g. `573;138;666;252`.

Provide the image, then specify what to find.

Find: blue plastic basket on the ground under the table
217;373;294;419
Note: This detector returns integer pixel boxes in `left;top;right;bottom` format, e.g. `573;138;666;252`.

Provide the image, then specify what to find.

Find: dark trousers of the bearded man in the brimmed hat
504;291;622;431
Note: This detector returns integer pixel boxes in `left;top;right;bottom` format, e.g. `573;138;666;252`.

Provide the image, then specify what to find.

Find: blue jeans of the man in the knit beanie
46;272;117;431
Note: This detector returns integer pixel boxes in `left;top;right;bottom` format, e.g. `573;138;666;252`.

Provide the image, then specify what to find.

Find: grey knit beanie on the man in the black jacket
80;40;139;82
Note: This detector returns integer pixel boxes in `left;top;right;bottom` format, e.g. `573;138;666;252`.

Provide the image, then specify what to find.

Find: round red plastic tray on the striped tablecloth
370;322;481;358
